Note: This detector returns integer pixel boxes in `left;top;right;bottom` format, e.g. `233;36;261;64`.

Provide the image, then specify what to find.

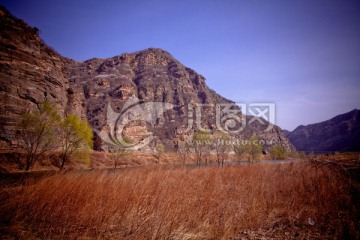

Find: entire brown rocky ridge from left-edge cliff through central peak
0;8;292;151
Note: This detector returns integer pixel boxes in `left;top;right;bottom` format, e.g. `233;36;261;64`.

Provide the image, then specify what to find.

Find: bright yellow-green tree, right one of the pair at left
55;114;93;170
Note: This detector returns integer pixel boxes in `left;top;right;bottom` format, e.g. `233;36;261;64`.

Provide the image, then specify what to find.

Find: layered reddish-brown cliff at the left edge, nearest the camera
0;8;69;148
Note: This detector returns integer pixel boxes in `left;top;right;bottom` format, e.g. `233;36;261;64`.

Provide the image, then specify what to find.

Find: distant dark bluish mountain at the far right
286;109;360;153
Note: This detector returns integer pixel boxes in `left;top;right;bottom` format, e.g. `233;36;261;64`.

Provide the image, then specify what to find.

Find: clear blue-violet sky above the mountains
0;0;360;130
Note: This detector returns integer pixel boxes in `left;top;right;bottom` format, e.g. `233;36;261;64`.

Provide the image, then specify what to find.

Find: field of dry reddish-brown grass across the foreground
0;162;359;239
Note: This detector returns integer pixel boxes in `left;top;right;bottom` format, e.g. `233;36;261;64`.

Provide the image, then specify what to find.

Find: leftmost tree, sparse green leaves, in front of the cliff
18;101;61;171
